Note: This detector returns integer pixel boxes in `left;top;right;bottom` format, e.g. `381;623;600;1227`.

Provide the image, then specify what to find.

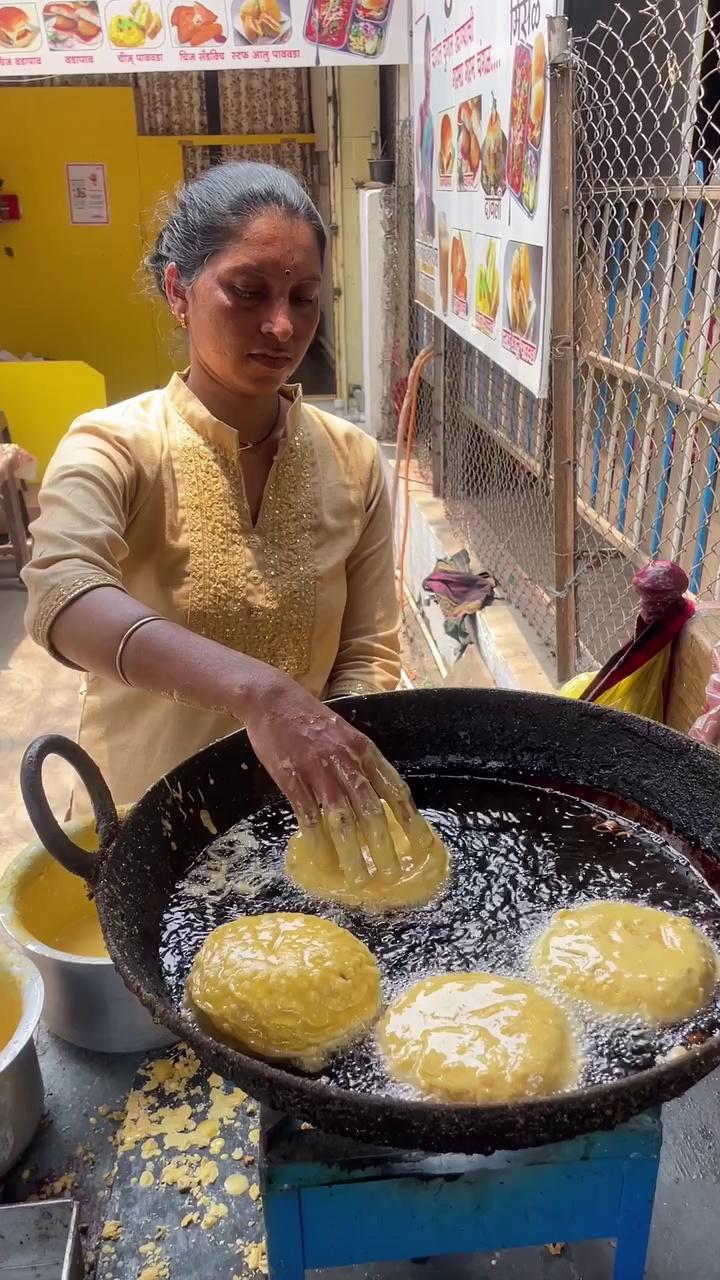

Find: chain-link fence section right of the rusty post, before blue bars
574;0;720;658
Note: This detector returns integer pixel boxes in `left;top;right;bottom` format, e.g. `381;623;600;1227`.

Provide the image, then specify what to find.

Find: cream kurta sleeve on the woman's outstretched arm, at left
23;419;137;666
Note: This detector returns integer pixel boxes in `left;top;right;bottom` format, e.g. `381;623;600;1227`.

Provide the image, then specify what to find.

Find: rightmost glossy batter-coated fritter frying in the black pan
530;902;717;1023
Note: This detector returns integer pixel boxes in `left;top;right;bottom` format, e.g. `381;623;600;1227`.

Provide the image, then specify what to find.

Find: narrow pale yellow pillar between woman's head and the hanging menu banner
340;67;380;387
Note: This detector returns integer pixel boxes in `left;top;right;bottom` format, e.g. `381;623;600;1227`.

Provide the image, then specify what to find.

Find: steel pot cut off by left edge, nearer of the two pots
0;946;45;1178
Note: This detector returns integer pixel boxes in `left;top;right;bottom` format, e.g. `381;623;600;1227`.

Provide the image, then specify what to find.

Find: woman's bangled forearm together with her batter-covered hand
51;586;425;883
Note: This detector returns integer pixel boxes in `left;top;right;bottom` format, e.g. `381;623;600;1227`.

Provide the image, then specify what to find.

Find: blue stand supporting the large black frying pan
260;1110;662;1280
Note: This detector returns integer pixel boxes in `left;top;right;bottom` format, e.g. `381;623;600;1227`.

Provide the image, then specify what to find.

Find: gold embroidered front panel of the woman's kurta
177;420;318;678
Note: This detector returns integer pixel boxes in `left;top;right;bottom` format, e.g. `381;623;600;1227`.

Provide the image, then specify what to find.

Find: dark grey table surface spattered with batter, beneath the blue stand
0;1032;720;1280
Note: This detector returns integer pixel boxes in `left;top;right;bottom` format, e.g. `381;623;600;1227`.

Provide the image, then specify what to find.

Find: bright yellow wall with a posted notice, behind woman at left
0;86;182;407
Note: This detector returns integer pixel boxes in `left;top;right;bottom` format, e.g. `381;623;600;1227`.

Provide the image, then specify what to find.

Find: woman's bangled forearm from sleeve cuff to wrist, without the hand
51;586;280;721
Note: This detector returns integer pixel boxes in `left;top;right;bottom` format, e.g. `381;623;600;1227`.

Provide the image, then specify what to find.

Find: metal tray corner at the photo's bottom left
0;1199;83;1280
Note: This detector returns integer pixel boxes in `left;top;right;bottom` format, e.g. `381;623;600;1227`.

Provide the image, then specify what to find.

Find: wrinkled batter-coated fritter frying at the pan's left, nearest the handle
187;911;380;1071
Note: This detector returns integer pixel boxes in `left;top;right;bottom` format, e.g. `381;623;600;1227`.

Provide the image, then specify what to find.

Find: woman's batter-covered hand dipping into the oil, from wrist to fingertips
245;672;433;884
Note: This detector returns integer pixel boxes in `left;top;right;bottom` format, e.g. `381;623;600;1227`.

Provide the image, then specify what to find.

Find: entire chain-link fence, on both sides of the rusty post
394;0;720;667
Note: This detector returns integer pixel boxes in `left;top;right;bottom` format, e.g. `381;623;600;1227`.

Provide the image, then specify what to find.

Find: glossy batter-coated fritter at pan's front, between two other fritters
378;973;578;1103
